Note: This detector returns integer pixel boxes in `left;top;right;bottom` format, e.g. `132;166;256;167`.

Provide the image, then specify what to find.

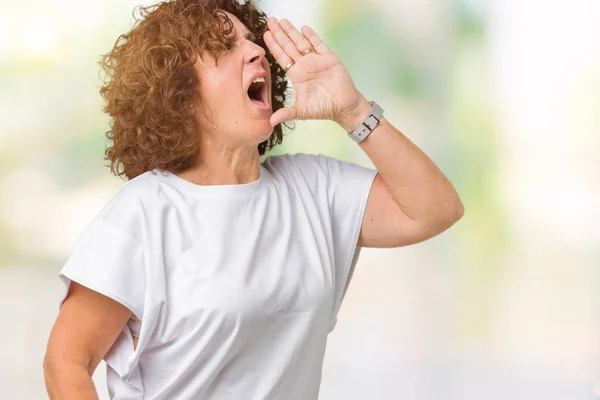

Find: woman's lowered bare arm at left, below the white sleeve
44;282;131;400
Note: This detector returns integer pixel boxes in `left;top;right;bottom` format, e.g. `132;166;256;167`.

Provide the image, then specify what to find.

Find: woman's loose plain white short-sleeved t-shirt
59;154;377;400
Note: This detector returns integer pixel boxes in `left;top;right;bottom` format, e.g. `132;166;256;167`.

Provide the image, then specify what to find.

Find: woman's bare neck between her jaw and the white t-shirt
177;142;260;185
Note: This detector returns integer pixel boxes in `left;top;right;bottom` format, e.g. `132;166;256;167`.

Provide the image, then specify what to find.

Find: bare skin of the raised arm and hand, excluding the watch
264;17;464;247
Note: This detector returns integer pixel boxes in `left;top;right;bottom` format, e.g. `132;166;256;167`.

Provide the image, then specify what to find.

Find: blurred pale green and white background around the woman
0;0;600;400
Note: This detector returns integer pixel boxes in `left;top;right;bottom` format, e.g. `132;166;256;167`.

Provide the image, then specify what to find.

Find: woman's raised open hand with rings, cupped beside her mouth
263;17;366;126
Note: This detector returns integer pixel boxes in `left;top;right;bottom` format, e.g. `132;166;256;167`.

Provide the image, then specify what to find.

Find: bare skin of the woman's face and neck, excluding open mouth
177;12;273;185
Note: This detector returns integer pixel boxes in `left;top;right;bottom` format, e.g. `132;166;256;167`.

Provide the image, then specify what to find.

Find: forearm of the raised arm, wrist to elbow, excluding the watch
338;95;463;226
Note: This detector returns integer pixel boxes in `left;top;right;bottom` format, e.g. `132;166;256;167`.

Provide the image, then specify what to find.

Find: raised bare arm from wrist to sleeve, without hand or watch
339;95;464;247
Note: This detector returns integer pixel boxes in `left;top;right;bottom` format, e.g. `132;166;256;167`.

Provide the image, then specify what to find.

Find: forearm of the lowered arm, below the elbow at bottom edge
44;361;98;400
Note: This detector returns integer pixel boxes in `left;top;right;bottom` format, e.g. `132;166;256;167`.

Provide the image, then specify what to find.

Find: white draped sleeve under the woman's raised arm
319;155;377;330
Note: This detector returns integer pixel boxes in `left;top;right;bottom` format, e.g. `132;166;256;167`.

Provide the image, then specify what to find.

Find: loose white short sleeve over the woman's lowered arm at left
59;191;146;320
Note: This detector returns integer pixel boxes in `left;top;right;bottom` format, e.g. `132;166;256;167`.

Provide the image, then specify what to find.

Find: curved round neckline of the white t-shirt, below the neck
154;164;268;197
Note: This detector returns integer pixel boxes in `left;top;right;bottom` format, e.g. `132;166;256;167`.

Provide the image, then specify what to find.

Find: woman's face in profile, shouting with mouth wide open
195;12;273;147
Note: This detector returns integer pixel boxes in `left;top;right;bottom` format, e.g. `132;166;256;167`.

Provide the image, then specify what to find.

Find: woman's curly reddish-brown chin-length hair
99;0;288;179
